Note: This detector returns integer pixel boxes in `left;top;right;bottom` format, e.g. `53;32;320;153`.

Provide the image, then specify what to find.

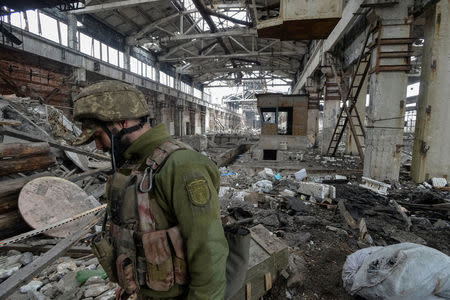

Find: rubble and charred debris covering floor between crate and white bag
219;163;450;299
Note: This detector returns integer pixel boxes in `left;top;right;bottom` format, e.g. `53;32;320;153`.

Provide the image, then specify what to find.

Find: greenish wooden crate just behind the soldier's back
232;224;288;300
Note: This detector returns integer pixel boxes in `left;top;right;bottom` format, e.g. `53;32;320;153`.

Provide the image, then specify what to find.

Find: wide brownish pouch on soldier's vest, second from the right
142;230;174;291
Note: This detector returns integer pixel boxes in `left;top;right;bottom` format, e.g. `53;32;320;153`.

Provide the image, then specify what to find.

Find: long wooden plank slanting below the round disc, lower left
0;218;99;299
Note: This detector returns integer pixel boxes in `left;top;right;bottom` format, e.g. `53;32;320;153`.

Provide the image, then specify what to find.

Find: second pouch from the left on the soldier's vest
111;224;139;295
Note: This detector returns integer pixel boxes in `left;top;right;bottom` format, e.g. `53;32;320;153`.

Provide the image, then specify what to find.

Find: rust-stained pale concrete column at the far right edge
411;0;450;182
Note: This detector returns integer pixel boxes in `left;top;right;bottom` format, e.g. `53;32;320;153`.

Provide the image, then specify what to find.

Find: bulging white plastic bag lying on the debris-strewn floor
342;243;450;300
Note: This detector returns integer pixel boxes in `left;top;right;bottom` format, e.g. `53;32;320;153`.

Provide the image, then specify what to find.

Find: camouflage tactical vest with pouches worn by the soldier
92;141;192;294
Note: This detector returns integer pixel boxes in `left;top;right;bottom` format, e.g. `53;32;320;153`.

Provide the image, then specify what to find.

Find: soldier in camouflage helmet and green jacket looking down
74;81;228;299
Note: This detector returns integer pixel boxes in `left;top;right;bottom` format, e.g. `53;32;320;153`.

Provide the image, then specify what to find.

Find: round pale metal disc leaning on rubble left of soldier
18;177;96;237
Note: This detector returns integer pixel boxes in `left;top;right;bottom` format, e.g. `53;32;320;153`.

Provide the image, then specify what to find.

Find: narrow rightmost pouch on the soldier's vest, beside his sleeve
167;226;188;285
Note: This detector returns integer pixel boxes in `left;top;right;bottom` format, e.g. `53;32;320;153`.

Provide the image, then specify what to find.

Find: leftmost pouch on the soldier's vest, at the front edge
91;234;117;282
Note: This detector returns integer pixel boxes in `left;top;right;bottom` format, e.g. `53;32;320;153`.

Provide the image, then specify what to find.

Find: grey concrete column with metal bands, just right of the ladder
364;1;411;181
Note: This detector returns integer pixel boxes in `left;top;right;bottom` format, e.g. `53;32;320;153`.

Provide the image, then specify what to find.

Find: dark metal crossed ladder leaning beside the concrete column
327;25;378;162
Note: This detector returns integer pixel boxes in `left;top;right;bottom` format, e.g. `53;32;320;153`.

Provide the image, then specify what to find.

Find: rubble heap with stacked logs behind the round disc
0;97;111;239
